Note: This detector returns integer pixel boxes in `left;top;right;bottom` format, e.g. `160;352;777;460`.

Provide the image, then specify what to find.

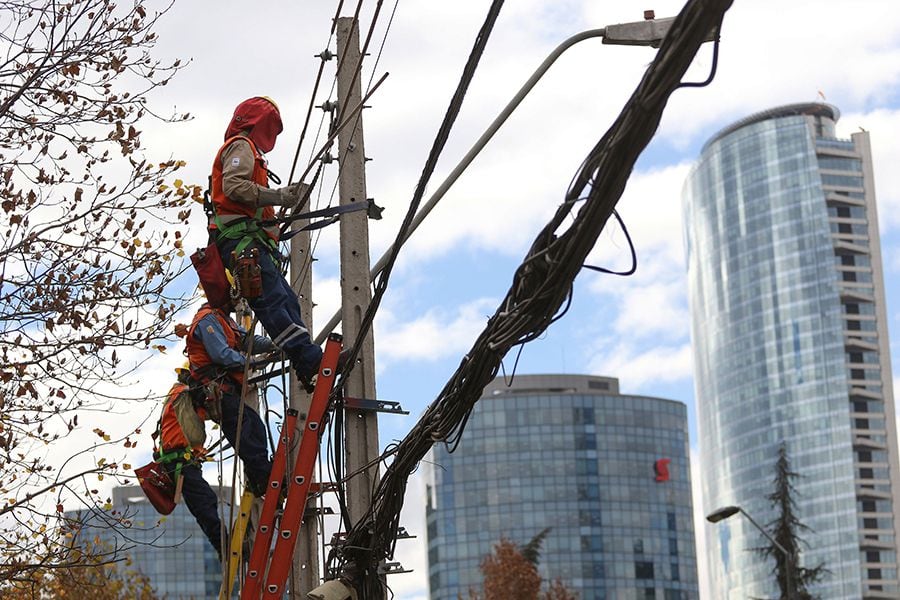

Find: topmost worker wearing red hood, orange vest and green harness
209;97;322;389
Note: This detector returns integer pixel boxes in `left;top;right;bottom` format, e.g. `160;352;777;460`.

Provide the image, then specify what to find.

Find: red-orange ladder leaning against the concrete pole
236;333;342;600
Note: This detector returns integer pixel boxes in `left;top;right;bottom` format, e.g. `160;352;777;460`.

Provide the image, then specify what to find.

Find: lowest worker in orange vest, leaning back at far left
153;366;222;560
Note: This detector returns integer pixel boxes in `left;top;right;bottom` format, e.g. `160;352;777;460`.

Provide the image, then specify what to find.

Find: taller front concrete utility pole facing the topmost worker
337;17;379;580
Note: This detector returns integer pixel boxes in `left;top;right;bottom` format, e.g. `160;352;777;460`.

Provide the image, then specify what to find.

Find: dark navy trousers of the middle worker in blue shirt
222;383;272;493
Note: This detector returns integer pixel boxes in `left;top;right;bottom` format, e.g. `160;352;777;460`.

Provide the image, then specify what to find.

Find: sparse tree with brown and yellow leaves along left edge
0;0;200;580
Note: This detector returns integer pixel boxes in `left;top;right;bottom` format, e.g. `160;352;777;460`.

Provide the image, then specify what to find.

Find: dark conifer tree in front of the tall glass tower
755;442;828;600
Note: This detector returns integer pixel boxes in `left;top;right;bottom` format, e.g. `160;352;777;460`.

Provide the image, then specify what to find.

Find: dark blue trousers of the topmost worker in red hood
217;239;322;378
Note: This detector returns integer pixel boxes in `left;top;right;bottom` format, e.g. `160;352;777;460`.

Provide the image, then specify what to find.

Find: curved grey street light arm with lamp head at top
315;18;674;344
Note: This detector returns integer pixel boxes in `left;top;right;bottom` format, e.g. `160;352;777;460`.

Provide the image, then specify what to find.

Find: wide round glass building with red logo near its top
426;375;699;600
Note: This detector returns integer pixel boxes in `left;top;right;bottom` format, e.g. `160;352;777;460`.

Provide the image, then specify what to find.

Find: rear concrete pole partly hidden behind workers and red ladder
287;219;319;600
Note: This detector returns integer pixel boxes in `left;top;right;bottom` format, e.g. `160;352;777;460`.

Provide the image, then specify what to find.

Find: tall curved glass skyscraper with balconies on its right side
683;103;900;600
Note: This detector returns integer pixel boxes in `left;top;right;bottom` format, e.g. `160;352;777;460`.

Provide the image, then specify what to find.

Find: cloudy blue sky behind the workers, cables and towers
56;0;900;600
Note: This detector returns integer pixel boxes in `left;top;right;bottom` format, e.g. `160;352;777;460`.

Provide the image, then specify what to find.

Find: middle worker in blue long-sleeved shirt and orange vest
186;304;275;497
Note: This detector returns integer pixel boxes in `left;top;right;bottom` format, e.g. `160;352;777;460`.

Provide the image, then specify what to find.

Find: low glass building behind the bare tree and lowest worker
69;486;231;600
